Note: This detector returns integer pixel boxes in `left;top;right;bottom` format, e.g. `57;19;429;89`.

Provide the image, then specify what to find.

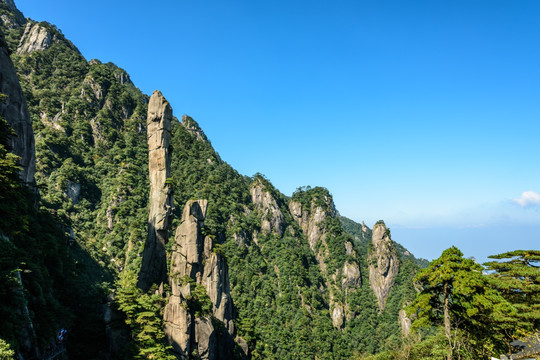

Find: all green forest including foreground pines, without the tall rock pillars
0;1;540;360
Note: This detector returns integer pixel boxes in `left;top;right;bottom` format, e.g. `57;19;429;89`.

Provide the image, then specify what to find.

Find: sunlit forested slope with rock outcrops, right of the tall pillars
167;122;420;358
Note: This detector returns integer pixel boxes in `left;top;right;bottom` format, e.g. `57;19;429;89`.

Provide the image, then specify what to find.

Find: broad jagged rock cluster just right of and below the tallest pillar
163;200;234;359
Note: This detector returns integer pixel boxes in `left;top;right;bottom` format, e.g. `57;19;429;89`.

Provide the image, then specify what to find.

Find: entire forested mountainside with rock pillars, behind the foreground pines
0;0;536;359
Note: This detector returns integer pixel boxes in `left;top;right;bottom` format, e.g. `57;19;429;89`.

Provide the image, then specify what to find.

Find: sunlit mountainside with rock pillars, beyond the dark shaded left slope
0;0;422;359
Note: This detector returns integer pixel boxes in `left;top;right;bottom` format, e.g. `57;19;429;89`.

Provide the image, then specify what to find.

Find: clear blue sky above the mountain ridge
16;0;540;261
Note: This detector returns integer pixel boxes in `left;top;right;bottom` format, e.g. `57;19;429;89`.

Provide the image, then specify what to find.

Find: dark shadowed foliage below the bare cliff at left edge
0;111;109;355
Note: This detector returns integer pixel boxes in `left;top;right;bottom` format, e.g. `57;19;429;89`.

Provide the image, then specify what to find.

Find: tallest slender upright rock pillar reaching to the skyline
138;91;173;291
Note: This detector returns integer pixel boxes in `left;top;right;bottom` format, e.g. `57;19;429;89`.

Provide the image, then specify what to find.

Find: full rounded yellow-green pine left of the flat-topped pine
407;247;515;360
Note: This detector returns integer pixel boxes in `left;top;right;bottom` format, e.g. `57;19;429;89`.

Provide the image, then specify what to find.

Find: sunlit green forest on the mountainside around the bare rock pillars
4;10;426;358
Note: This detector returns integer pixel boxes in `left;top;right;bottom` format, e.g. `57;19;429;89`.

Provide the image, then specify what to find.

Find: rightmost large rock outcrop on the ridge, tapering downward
368;221;399;311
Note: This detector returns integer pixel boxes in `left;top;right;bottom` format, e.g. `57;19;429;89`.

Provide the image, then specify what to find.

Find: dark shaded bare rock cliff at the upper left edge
0;28;36;186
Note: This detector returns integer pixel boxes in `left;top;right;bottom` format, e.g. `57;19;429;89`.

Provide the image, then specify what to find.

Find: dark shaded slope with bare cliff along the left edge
0;22;112;358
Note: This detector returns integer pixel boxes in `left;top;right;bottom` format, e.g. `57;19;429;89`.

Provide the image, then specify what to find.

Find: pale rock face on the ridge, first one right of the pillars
249;179;285;236
